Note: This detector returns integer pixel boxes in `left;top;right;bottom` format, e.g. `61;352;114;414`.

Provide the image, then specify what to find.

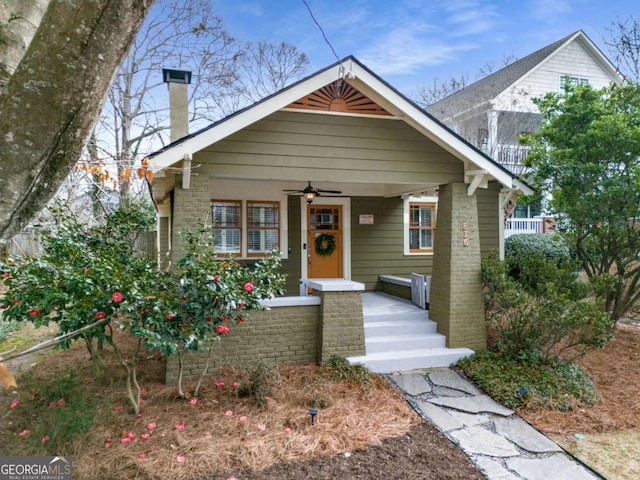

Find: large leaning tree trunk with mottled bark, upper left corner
0;0;154;243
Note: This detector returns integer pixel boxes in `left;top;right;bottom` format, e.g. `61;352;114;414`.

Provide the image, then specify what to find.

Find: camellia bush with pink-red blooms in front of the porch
0;201;284;414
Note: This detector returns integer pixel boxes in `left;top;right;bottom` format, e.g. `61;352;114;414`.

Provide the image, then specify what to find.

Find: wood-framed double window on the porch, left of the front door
211;200;281;258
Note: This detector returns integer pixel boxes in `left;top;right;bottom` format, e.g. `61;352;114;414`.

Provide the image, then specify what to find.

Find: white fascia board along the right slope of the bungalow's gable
347;64;513;188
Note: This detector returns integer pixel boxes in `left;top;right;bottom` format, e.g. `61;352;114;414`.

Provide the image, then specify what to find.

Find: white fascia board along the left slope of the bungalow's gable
149;65;340;172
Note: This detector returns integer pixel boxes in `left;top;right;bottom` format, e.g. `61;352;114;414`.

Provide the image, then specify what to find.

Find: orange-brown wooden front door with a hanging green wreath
307;204;343;278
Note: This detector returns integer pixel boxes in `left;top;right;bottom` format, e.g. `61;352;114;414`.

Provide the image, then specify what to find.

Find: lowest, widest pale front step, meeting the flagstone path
347;348;473;373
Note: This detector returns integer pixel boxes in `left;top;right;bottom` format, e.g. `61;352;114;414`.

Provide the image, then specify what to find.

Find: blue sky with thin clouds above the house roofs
214;0;640;94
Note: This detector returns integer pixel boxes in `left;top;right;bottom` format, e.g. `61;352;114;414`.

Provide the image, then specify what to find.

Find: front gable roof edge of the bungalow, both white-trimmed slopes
148;56;515;188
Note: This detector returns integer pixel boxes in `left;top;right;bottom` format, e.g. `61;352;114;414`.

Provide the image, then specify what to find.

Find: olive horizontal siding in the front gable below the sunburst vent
194;112;463;185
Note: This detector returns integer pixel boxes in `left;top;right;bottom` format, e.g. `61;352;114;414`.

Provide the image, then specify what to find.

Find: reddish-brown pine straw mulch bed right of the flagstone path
518;322;640;434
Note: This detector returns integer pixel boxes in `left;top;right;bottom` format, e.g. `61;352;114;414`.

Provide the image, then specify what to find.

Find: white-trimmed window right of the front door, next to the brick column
404;197;438;255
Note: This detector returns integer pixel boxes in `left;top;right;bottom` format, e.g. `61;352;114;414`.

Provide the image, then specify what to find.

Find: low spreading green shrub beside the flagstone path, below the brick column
458;350;596;410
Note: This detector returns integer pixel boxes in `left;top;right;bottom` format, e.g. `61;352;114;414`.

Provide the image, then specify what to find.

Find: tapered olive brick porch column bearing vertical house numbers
429;183;487;350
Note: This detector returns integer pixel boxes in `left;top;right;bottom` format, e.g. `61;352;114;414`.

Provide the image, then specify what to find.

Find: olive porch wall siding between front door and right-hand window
351;197;437;290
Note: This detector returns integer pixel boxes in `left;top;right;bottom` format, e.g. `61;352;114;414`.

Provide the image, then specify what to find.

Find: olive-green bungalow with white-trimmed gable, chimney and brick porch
149;57;529;376
